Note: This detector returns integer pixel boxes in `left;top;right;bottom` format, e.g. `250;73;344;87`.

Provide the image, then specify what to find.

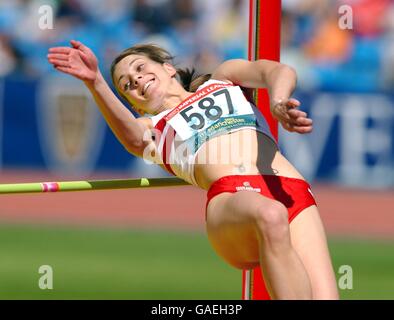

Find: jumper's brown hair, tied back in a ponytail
111;44;211;104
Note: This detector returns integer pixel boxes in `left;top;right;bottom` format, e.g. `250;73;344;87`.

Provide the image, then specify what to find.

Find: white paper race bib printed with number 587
166;84;255;141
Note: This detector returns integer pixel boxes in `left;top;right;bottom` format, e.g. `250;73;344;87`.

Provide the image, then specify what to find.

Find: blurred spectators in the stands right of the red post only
282;0;394;92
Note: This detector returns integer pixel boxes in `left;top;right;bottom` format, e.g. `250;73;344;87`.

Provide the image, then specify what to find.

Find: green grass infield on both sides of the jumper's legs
0;225;394;299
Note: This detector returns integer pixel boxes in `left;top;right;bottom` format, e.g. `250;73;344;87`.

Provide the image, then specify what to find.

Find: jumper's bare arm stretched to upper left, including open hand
48;40;150;156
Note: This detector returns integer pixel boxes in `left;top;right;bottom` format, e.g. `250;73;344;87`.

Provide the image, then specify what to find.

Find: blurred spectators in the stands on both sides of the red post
0;0;394;91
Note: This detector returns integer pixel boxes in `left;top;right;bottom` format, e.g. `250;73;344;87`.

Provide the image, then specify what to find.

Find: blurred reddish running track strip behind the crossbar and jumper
0;170;394;238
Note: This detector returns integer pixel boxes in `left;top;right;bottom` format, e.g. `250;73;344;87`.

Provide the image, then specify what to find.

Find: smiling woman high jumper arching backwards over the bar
48;40;338;299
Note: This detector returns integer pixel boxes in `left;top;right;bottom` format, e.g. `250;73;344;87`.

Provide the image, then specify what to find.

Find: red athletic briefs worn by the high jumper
206;175;316;223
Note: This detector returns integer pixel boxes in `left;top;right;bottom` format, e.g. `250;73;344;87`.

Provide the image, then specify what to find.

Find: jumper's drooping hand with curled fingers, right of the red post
271;98;313;133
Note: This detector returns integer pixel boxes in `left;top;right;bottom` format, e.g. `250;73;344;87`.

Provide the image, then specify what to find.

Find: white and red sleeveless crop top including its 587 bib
149;80;276;186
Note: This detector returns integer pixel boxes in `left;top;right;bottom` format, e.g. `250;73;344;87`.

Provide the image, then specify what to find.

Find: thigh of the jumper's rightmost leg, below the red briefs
290;206;338;299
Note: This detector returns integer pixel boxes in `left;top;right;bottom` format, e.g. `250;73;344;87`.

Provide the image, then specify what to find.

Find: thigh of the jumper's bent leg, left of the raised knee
206;191;287;269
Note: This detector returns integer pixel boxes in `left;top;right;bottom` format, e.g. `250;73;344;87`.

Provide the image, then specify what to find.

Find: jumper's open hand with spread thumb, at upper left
47;40;98;82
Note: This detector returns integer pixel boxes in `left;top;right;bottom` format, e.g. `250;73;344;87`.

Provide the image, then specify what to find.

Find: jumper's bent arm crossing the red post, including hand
212;59;312;133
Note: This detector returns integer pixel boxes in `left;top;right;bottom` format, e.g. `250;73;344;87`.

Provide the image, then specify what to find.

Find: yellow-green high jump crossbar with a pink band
0;178;189;195
